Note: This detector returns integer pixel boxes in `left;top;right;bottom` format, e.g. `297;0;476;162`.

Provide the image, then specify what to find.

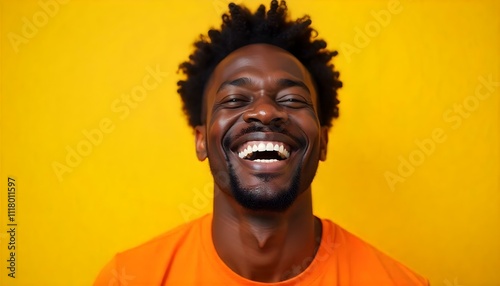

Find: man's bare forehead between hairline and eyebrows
206;44;313;91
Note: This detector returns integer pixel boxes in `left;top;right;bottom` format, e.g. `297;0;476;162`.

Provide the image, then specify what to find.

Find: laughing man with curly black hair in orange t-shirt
95;1;428;285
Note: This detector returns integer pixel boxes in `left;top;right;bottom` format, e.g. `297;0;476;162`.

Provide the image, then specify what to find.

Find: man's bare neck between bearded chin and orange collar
212;188;321;282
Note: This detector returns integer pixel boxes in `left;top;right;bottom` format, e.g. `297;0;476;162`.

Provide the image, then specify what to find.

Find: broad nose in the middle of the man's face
243;96;288;126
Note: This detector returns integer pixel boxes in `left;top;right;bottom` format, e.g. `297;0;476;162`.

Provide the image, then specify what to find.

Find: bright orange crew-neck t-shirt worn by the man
94;214;428;286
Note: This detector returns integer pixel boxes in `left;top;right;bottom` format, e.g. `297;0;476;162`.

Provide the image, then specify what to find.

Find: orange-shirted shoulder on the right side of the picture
322;219;428;285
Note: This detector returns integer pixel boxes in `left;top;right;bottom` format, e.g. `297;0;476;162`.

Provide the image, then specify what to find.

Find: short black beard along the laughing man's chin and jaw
228;162;302;212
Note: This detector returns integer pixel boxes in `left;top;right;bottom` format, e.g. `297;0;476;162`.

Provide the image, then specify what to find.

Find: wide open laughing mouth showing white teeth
238;141;290;163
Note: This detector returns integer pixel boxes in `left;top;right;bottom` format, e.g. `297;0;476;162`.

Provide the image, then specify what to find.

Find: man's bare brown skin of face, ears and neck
195;44;328;282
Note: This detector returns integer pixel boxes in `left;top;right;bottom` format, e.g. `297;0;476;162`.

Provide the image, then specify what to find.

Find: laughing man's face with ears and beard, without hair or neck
196;44;328;211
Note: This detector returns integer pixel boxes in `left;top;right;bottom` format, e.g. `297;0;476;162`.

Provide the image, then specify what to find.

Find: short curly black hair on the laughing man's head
177;0;342;127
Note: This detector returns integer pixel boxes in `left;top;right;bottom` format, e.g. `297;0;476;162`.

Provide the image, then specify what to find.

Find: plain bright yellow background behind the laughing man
0;0;500;286
